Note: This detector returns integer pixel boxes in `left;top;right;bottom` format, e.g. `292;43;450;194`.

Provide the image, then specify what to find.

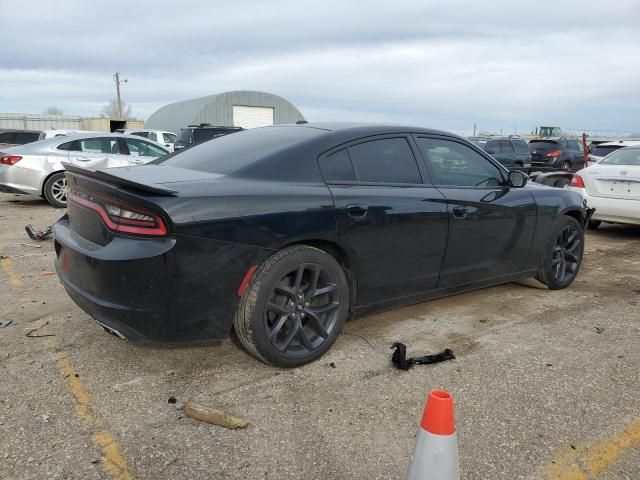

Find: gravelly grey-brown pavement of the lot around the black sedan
0;194;640;480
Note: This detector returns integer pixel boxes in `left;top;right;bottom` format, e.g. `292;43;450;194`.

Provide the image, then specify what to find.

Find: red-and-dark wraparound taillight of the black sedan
67;189;167;237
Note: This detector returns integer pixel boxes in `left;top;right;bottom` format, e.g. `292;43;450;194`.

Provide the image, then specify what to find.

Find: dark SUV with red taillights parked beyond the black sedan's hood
529;138;584;170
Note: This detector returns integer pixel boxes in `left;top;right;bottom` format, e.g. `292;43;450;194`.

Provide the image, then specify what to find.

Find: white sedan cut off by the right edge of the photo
569;146;640;228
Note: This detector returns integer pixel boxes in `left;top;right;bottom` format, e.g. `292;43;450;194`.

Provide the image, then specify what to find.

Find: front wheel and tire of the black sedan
536;215;584;290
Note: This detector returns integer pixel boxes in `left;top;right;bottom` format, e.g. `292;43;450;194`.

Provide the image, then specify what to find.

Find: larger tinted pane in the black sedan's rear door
349;138;422;183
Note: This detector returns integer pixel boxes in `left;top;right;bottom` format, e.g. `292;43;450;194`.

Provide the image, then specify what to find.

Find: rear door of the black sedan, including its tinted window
319;135;448;306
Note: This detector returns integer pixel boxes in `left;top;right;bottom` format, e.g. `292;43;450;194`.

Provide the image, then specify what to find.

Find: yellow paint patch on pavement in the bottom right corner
547;418;640;480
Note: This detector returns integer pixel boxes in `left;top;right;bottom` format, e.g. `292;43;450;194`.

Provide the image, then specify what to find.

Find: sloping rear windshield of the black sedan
154;127;326;175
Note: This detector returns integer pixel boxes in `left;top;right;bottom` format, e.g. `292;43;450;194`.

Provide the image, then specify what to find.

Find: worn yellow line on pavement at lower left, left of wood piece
38;323;133;480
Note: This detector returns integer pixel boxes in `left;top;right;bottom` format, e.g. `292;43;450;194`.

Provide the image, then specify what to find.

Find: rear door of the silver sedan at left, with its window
68;137;129;171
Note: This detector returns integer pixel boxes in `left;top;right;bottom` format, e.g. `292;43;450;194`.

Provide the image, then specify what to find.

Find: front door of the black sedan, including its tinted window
416;136;536;288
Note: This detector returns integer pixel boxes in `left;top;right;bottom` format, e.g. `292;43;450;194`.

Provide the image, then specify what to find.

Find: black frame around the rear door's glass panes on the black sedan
317;133;432;188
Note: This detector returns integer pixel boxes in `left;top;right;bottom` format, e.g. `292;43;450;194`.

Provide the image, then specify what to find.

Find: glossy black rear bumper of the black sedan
54;217;270;343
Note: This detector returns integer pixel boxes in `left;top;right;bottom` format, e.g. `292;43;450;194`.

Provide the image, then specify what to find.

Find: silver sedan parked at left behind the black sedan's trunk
0;132;169;208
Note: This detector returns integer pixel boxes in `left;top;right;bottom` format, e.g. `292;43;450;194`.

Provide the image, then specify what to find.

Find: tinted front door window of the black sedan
418;137;504;187
